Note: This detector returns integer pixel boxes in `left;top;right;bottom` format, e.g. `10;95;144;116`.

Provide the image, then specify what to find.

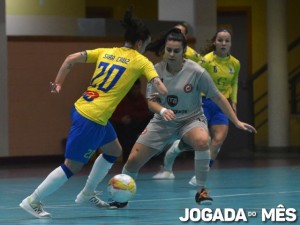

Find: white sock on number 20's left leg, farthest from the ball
30;166;68;203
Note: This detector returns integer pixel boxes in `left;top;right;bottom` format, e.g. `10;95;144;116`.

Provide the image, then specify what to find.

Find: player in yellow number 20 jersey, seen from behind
20;9;167;218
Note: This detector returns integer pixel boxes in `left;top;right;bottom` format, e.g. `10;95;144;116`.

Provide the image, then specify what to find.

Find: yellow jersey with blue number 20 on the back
75;47;158;125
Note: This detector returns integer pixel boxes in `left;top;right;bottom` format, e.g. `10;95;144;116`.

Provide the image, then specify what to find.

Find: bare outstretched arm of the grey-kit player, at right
211;93;257;133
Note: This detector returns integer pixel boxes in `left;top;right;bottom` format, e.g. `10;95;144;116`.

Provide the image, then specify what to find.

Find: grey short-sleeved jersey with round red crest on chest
146;59;219;121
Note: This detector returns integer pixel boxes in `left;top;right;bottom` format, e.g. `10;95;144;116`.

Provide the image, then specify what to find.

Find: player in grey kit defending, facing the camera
122;28;256;204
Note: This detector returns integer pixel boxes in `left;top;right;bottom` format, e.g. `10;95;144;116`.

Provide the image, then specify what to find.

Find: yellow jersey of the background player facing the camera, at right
199;52;241;103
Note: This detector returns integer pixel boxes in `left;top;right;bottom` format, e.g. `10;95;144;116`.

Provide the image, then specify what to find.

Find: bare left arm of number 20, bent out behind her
50;51;87;93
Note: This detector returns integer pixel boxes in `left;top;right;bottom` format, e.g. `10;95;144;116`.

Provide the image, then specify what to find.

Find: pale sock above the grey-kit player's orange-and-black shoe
195;149;210;191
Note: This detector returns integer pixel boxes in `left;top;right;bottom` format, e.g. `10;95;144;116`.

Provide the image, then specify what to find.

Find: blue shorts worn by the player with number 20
65;107;117;164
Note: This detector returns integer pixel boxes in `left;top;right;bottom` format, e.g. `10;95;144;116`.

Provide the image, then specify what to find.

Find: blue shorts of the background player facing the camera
202;97;229;127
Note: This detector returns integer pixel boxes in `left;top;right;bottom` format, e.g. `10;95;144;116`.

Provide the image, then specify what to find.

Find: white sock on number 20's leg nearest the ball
82;154;113;195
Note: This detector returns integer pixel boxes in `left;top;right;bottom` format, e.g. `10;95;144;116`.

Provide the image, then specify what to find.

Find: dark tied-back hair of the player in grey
146;28;187;56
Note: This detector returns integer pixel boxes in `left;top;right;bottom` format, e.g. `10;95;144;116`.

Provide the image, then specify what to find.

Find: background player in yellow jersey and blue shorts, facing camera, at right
153;28;240;186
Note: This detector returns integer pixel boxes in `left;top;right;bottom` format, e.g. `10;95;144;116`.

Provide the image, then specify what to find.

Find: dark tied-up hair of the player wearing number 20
120;7;151;44
